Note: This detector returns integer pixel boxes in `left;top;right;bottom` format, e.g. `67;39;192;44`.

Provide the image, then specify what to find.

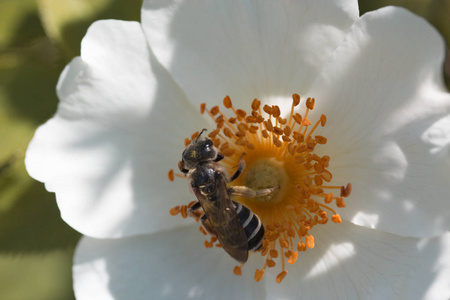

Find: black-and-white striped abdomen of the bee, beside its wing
233;201;264;251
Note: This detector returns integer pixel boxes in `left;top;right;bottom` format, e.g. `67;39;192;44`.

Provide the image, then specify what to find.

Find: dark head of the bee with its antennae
182;129;219;169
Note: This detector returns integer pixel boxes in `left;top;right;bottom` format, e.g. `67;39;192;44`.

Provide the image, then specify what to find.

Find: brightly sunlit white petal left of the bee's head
26;20;205;237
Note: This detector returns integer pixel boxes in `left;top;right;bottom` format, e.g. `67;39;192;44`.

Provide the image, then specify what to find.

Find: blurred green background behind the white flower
0;0;450;300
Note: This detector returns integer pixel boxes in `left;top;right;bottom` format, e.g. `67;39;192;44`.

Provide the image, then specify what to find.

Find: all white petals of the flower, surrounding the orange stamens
26;0;450;299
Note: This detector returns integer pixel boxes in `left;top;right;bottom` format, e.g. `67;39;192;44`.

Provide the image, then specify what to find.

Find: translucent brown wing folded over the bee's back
194;176;248;263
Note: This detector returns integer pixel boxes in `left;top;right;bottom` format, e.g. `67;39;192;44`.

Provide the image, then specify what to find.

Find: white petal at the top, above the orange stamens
142;0;358;105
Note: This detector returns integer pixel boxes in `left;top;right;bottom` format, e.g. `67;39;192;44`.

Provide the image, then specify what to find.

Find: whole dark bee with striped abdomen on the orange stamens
178;129;279;263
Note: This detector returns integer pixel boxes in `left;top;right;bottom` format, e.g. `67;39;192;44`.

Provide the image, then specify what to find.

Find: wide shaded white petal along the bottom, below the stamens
73;222;450;300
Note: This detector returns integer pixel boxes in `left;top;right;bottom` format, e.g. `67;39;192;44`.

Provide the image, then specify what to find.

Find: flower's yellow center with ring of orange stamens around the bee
169;94;351;283
